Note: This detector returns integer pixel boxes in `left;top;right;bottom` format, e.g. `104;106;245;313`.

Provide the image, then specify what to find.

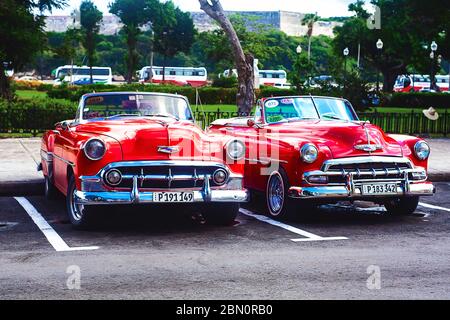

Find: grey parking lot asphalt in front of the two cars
0;183;450;300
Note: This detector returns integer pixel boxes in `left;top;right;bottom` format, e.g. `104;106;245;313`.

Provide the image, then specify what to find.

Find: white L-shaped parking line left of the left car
14;197;99;251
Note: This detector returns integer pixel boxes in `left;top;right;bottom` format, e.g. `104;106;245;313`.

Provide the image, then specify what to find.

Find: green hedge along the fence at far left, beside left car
0;99;77;134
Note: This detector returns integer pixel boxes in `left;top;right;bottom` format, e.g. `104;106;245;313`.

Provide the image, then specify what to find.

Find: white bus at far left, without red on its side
54;65;112;85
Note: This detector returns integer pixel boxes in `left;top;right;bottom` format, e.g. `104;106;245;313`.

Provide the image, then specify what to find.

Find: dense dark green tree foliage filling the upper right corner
334;0;450;91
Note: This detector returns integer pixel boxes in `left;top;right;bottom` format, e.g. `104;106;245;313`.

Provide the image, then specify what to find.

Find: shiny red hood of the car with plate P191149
76;118;210;161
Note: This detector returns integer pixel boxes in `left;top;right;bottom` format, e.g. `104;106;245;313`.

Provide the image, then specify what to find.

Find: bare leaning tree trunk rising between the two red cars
199;0;255;116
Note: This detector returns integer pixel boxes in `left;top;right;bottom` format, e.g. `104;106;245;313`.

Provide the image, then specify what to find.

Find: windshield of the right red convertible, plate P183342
264;97;358;123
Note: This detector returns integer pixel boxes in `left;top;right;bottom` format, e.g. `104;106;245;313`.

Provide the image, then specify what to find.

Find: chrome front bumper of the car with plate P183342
288;168;436;200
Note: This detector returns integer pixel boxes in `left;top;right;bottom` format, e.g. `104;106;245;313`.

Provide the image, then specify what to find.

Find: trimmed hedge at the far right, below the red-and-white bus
382;92;450;108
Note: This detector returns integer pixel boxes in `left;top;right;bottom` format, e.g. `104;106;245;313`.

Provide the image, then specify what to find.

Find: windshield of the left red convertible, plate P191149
82;94;193;120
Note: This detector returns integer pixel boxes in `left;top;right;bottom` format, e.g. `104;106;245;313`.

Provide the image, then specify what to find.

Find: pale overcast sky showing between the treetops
52;0;355;17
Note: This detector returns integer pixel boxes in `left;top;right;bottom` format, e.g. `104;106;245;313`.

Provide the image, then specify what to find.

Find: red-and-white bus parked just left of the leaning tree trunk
139;67;208;87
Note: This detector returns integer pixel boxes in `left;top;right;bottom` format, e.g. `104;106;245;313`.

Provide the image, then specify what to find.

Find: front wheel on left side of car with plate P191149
66;175;95;229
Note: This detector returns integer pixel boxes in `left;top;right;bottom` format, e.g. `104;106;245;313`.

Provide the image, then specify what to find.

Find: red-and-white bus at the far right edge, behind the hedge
394;74;449;92
